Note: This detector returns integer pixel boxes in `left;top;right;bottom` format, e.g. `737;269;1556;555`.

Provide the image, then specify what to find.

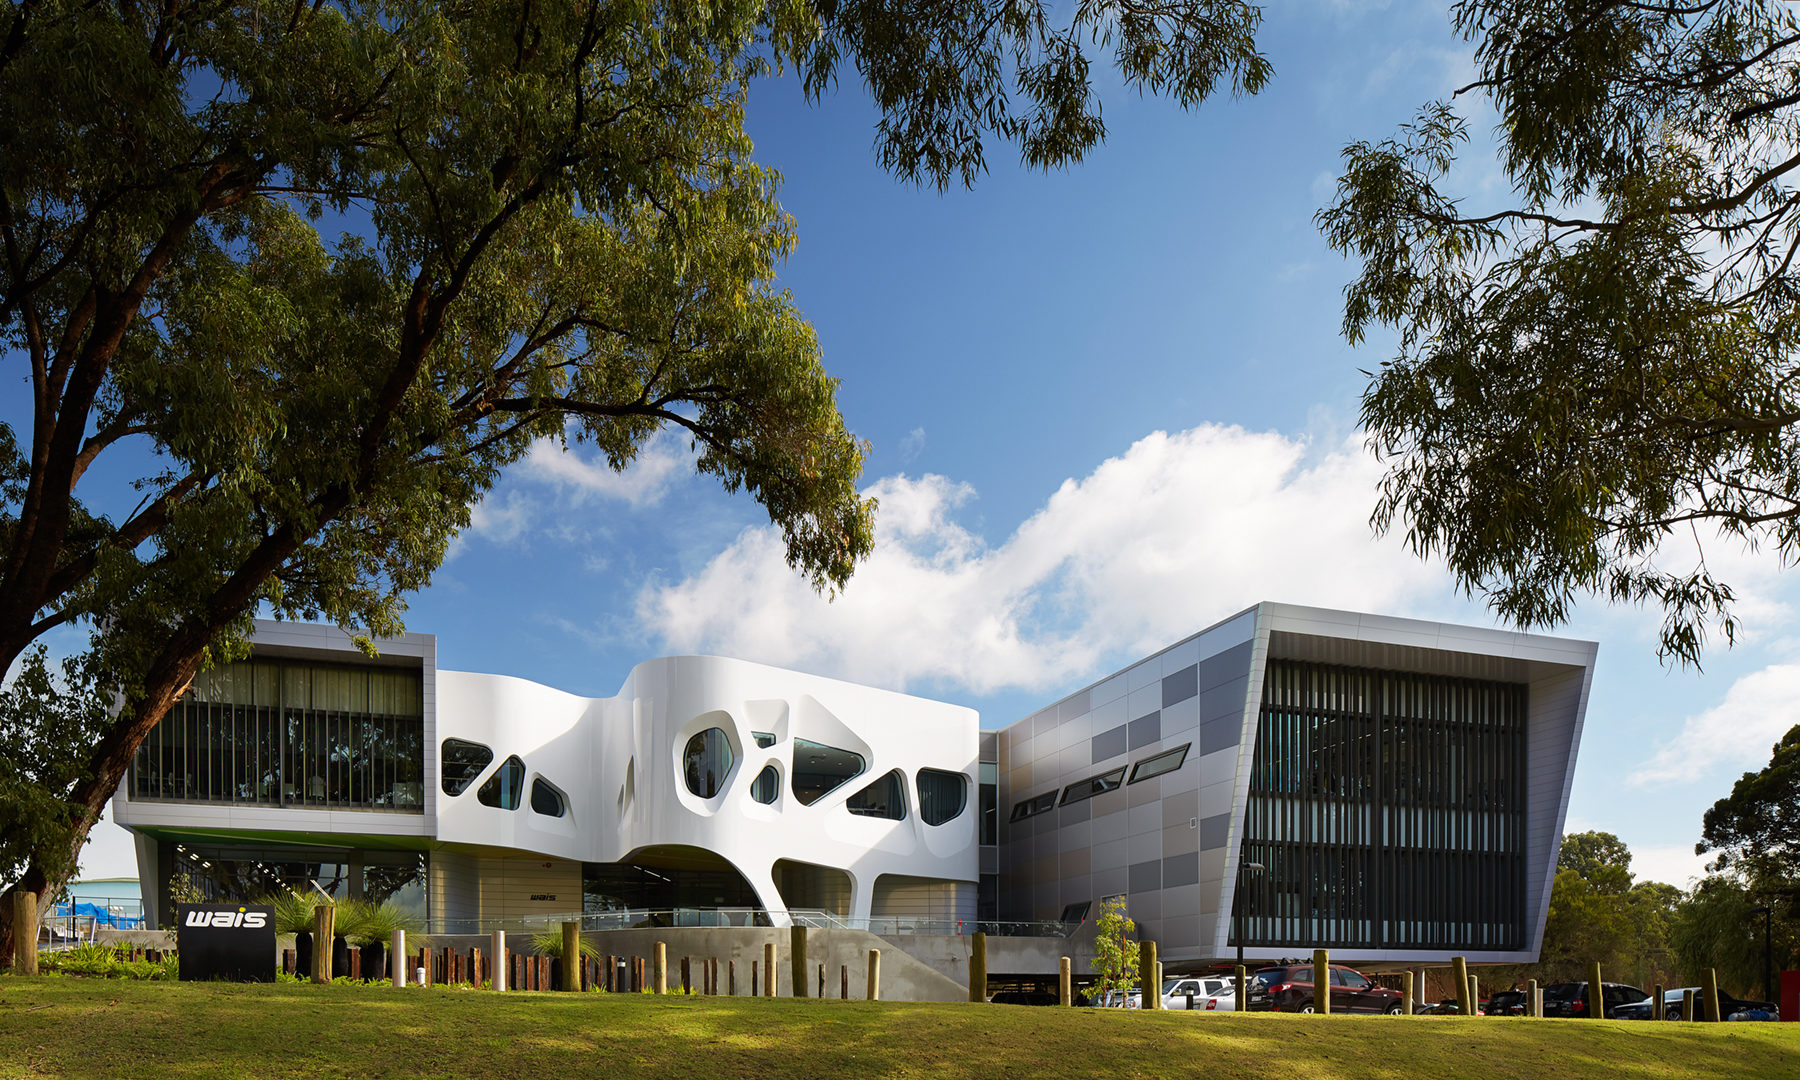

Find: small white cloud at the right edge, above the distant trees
1631;664;1800;785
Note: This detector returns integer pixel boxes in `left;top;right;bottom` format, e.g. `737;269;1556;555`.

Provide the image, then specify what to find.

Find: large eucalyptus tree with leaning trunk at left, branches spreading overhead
0;0;1269;956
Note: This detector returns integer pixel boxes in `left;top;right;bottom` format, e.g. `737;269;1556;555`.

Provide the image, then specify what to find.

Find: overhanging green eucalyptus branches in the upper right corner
1318;0;1800;662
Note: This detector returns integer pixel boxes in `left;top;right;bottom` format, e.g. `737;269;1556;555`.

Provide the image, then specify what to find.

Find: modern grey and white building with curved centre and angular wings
112;603;1595;965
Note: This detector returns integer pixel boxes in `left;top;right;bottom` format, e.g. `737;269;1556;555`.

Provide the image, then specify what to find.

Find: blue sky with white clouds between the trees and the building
63;2;1800;884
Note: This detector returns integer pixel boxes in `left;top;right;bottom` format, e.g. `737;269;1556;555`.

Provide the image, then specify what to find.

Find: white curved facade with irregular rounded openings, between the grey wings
436;657;977;923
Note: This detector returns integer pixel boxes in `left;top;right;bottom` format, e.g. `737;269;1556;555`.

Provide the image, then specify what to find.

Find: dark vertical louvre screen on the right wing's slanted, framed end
1231;661;1526;950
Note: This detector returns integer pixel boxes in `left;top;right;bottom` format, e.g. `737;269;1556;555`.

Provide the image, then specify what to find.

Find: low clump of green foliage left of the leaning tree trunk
0;646;110;896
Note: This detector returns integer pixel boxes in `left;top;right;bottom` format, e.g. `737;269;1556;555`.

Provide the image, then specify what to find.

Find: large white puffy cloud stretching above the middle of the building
637;425;1444;693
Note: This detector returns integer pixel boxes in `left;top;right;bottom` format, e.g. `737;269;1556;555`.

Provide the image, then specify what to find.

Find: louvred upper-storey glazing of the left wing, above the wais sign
130;661;425;814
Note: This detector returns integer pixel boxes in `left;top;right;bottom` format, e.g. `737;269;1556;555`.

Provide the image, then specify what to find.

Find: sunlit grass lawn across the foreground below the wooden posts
0;976;1800;1080
